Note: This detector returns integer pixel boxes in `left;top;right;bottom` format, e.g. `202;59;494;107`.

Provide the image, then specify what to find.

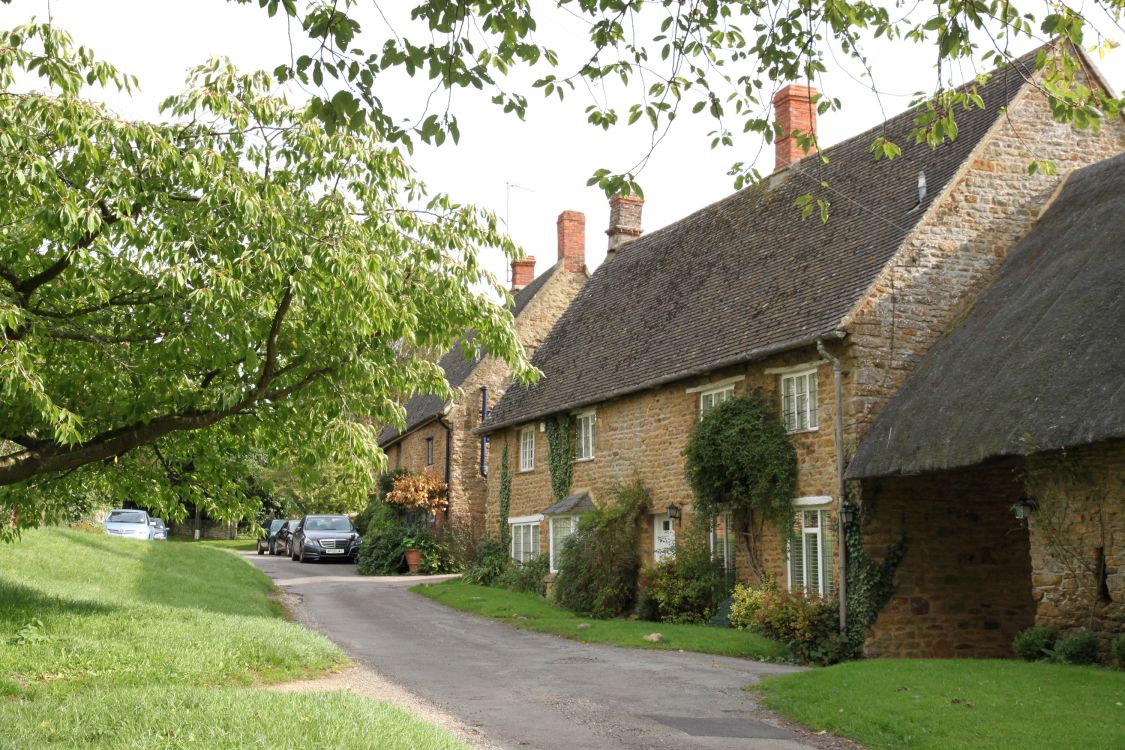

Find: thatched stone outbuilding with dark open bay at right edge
847;155;1125;657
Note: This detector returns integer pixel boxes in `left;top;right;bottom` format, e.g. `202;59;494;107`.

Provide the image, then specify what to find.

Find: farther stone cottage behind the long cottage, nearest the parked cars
379;211;586;530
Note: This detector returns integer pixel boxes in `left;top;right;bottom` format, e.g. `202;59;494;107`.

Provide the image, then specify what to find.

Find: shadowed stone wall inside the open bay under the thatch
863;466;1035;658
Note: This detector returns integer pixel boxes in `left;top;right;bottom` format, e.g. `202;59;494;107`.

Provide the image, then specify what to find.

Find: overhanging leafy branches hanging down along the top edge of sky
217;0;1125;195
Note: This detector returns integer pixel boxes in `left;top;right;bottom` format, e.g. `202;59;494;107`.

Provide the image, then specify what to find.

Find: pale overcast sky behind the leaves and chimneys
0;0;1125;287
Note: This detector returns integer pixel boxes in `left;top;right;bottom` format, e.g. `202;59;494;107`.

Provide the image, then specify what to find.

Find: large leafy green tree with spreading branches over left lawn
0;25;529;537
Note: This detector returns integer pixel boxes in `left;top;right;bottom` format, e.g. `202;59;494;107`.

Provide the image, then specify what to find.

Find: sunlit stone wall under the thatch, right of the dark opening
1026;441;1125;648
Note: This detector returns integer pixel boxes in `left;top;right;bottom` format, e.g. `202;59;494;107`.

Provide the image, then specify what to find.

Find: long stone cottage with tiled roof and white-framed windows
483;48;1125;656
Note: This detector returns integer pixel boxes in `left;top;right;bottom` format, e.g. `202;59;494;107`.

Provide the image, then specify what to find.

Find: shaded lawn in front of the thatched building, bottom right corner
749;659;1125;750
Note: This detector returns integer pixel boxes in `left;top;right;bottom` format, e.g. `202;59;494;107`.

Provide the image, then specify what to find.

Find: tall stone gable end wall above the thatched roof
843;74;1125;444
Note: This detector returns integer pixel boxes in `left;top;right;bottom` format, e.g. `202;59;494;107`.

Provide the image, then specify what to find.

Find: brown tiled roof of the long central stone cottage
485;57;1029;430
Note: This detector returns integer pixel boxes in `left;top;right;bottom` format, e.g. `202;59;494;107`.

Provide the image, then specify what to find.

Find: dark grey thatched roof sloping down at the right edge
847;154;1125;479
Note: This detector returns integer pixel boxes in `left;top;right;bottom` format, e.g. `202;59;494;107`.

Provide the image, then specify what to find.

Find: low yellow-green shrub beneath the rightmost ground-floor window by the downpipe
730;585;848;665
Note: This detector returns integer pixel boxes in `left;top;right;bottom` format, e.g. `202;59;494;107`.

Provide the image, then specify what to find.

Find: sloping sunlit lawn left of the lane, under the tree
0;530;465;749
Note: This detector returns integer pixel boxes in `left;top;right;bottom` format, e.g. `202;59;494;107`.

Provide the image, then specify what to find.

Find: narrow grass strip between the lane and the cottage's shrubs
411;580;786;660
